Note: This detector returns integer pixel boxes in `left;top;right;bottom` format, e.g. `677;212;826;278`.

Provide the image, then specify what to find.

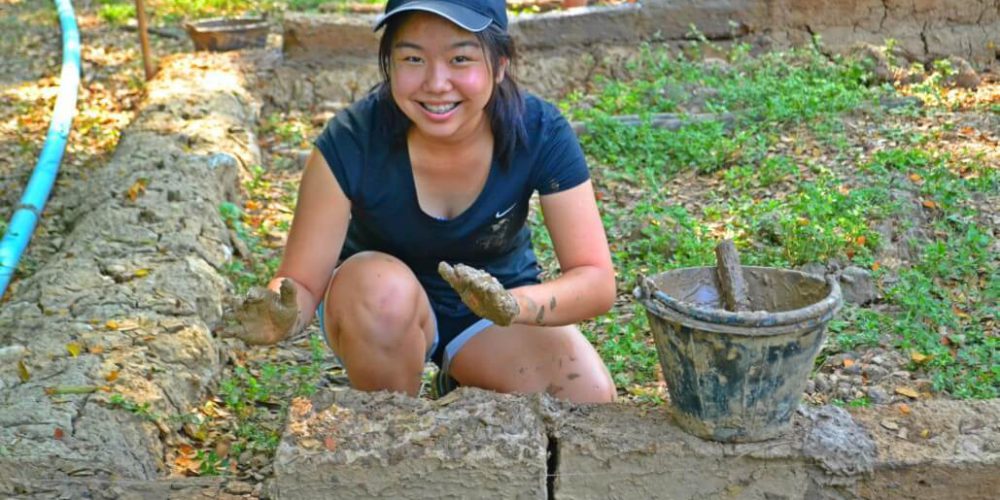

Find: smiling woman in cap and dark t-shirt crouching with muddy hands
227;0;616;402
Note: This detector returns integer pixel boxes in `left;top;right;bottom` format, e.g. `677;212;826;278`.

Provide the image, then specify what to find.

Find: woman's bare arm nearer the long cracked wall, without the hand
267;148;351;342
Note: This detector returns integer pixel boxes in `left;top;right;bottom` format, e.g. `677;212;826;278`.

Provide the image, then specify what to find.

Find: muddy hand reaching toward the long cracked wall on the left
221;279;299;345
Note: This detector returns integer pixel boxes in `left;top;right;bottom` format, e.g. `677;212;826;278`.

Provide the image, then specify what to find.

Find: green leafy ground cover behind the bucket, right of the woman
552;38;1000;398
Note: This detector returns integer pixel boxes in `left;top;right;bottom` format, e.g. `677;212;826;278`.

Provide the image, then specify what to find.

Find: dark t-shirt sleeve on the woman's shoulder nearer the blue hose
314;108;366;201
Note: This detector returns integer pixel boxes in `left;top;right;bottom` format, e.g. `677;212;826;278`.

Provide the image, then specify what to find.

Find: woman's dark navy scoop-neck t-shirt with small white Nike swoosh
316;93;589;312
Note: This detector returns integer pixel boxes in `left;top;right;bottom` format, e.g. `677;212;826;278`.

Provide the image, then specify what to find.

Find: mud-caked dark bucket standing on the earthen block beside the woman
635;266;842;442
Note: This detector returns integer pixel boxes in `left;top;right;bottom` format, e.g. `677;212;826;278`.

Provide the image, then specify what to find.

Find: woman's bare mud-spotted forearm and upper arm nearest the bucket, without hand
511;181;617;325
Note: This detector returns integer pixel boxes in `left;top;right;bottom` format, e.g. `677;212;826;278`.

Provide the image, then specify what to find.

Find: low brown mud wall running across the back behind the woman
266;0;1000;109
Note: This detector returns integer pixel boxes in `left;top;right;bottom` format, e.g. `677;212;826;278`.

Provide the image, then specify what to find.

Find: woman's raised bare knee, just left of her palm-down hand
326;252;424;345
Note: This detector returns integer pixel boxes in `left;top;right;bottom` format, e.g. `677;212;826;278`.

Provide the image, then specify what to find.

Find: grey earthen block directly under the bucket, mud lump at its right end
548;405;875;499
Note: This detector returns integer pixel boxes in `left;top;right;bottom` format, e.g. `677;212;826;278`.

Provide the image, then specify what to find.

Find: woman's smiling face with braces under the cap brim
390;13;503;141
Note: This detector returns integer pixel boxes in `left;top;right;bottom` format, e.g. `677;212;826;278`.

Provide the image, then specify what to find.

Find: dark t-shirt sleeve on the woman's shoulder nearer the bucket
533;104;590;195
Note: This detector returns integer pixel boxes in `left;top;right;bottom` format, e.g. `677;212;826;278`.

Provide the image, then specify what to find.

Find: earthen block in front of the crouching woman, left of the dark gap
273;388;547;499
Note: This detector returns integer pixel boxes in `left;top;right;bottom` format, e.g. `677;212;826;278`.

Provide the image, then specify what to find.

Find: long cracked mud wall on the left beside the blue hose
0;52;259;496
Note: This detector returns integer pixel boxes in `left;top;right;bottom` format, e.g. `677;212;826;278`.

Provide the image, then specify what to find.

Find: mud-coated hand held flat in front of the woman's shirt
438;262;520;326
